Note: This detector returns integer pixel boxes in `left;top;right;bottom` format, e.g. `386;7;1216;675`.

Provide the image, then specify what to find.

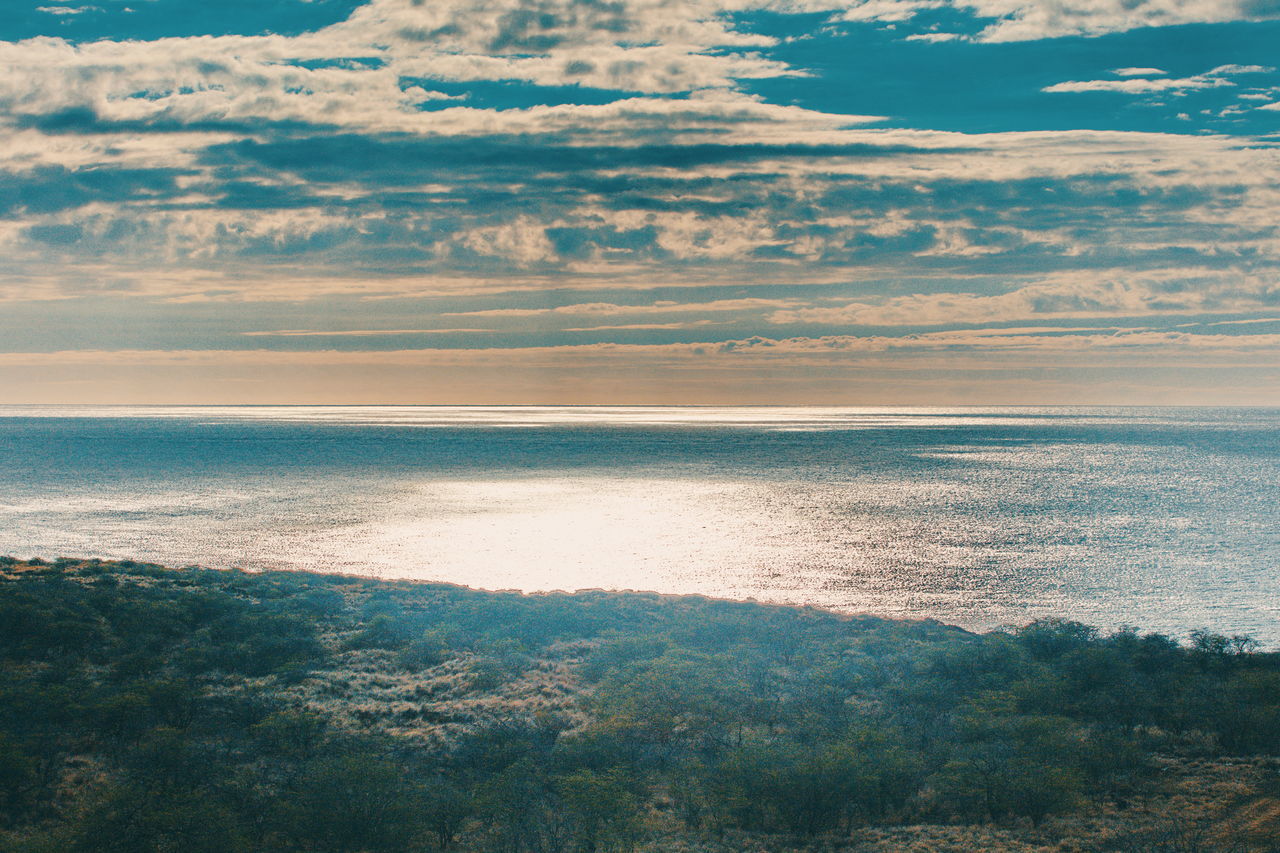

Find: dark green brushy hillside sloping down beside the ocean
0;558;1280;853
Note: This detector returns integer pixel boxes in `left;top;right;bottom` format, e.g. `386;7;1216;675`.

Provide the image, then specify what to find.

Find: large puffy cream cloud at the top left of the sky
0;0;824;132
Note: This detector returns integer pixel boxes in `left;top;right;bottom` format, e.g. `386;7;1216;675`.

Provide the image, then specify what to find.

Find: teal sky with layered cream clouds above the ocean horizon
0;0;1280;405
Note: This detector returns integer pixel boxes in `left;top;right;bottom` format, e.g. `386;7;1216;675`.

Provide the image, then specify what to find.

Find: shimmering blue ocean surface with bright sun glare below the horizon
0;406;1280;637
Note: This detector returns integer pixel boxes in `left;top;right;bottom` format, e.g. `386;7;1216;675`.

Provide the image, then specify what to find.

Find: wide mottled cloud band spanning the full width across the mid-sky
0;118;1280;298
